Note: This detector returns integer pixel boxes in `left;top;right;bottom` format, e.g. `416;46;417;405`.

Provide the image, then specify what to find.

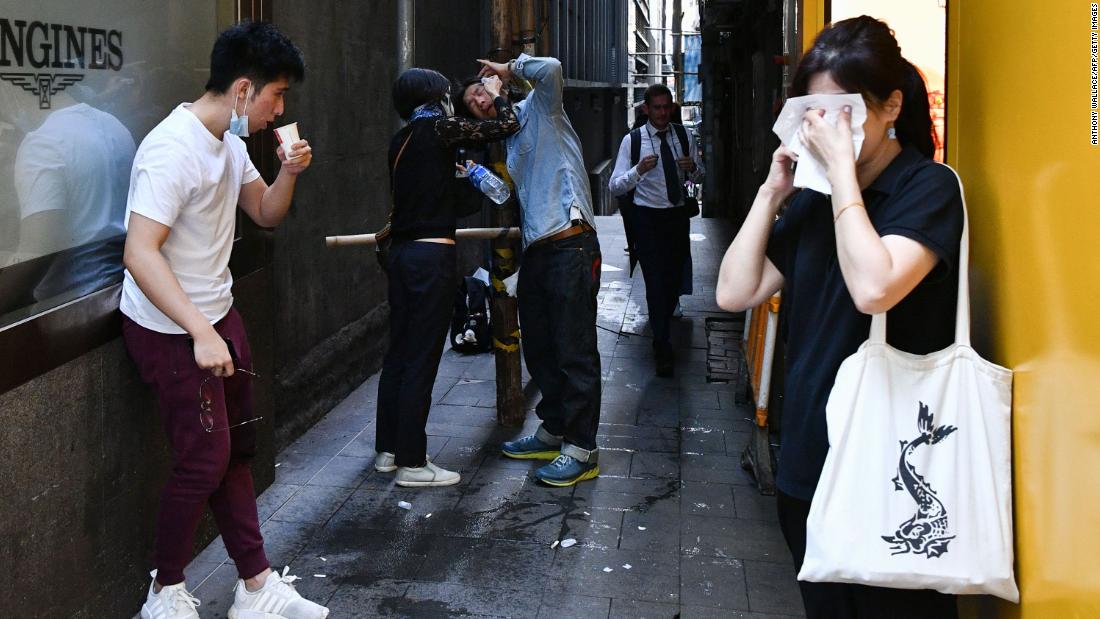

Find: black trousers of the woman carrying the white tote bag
777;493;958;619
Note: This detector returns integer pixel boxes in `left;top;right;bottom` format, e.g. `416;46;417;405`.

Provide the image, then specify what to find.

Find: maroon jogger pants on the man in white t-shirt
122;309;268;585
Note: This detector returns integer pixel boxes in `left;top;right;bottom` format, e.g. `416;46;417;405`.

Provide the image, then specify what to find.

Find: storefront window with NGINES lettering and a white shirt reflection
0;0;224;329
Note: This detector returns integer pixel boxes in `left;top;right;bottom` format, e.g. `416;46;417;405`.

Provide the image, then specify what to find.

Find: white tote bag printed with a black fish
799;167;1020;601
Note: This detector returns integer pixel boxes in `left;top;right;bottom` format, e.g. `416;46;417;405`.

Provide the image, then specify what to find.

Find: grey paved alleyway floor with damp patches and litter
188;217;802;619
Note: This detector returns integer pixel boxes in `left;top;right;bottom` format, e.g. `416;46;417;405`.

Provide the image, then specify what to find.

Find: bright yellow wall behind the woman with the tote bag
803;0;1100;619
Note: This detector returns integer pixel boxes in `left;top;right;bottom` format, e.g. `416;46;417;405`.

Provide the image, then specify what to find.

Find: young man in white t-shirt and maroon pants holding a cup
121;22;328;619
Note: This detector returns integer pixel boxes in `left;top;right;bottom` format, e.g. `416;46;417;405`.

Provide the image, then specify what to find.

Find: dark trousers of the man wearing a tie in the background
630;205;690;355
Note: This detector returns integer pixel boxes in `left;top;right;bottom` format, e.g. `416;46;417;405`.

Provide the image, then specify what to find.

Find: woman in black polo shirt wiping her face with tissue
717;15;963;619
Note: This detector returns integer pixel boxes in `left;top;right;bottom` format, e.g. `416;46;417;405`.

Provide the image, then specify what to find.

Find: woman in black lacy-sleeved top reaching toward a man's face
374;68;519;487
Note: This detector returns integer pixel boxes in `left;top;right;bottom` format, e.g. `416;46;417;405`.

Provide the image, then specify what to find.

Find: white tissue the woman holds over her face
771;95;867;196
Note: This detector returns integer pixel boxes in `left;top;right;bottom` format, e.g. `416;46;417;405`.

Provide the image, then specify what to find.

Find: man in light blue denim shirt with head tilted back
462;54;601;486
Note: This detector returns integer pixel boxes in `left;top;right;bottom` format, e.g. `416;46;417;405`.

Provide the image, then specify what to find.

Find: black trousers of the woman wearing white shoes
374;241;455;466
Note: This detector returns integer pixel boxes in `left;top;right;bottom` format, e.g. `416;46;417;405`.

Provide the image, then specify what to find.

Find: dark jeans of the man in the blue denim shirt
518;232;602;451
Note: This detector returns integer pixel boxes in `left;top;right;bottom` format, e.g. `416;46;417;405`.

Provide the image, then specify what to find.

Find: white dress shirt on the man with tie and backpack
608;122;703;209
